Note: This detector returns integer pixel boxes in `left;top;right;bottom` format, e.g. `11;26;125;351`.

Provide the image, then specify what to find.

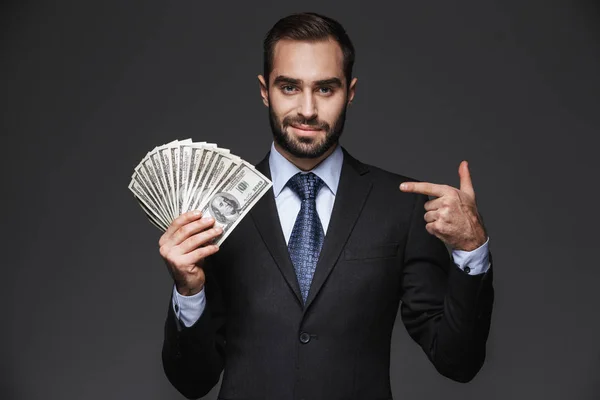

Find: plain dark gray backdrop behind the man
0;0;600;400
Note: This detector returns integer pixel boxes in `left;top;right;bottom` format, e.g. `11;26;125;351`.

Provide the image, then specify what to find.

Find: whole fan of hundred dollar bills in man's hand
129;139;272;246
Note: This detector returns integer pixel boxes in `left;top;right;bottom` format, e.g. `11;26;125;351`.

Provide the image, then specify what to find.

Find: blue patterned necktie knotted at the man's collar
287;172;325;303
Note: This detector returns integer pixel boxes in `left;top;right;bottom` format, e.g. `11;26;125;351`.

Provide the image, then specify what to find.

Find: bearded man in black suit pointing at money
159;13;493;400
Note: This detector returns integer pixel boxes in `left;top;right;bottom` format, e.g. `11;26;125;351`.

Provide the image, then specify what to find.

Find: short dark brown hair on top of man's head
263;13;354;86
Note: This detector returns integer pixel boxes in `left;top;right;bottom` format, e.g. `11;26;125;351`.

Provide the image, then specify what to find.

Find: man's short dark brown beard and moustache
269;105;347;158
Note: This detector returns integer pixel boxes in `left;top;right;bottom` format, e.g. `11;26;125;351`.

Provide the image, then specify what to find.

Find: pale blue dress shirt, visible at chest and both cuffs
173;143;490;327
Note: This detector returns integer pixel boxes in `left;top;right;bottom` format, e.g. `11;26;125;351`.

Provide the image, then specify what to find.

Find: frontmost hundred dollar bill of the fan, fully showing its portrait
199;160;272;246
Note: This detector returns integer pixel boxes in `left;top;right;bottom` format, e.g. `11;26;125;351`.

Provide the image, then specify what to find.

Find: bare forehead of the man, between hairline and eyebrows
271;39;344;83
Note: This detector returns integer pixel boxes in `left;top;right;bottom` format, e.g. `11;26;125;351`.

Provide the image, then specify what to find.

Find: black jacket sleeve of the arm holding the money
162;257;226;399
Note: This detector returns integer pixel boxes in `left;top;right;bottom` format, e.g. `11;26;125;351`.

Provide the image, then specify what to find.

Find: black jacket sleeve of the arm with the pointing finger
401;194;494;382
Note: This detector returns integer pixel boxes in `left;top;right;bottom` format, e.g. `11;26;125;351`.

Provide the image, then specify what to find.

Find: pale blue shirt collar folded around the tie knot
269;142;344;198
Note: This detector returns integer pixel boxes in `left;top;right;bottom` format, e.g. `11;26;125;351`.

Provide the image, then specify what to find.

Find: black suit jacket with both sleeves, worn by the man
162;149;493;400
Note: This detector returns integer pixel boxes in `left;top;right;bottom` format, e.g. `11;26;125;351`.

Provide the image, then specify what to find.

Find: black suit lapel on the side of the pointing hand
304;148;372;311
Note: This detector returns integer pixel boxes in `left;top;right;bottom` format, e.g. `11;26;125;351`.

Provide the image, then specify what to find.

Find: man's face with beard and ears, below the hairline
261;39;356;158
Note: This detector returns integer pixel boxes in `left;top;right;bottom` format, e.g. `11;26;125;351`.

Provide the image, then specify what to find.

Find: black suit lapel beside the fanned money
250;153;303;307
